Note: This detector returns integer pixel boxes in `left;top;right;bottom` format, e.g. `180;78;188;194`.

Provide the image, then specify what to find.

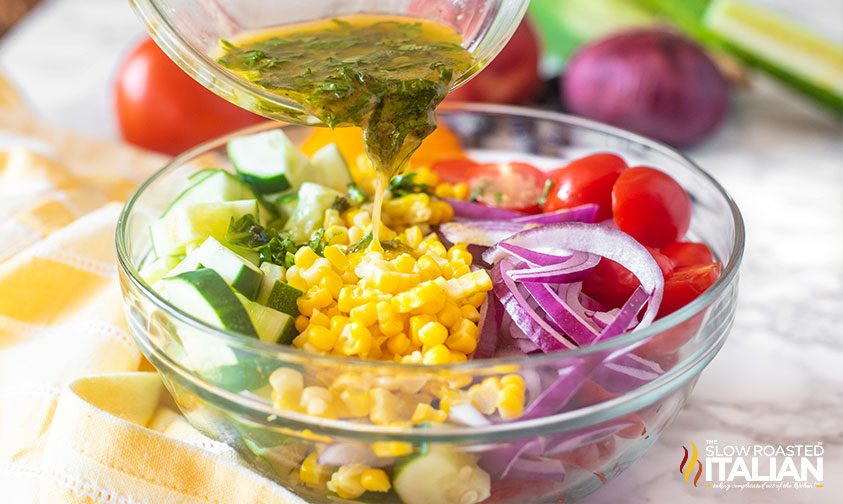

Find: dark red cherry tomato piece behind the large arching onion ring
582;247;673;308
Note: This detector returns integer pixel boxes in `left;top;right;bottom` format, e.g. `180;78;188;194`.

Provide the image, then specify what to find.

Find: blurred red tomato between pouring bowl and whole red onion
448;18;541;104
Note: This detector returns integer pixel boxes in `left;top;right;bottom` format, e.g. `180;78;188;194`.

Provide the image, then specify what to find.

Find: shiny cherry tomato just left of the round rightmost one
542;153;627;221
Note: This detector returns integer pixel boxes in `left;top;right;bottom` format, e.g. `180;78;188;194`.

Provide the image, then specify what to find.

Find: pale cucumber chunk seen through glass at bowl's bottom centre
392;446;492;504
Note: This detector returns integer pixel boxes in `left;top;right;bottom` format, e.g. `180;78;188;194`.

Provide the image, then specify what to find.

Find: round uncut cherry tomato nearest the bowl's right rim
612;167;691;247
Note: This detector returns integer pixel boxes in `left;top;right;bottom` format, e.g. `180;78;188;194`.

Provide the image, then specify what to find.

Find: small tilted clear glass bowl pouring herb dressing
130;0;529;124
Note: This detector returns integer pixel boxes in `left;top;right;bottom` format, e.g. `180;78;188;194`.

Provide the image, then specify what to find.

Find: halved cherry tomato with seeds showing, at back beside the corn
431;160;547;213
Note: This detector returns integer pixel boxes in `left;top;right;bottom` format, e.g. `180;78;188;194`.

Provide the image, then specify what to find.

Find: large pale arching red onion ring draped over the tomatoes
484;222;664;326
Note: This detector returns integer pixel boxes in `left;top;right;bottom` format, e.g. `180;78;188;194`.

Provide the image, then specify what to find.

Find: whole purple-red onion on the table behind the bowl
561;29;729;146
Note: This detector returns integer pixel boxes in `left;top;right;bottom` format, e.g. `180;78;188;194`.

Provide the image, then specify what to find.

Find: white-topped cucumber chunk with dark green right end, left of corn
167;236;263;300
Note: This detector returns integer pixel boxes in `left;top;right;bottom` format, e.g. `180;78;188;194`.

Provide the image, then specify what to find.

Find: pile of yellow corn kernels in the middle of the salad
270;170;525;499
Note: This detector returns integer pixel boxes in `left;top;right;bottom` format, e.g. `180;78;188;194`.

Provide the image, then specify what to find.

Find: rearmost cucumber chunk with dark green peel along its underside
228;129;312;194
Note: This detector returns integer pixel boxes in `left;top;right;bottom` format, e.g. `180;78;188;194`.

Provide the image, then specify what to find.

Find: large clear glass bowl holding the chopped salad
117;104;744;504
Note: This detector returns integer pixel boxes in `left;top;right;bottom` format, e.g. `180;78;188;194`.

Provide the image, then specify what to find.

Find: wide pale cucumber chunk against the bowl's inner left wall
151;199;260;257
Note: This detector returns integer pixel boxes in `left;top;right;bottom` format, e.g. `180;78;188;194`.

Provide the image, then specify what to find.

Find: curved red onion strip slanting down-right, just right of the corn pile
492;260;576;352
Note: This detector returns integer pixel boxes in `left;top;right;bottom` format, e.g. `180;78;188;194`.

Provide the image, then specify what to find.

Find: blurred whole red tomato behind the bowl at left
114;38;264;155
